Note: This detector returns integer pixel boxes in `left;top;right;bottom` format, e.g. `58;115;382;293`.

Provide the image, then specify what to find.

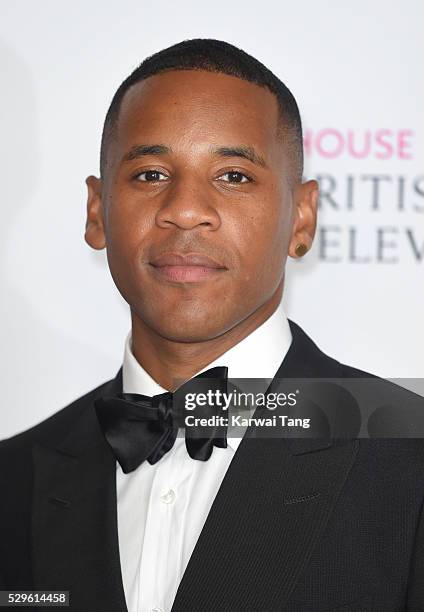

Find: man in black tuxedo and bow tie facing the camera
0;39;424;612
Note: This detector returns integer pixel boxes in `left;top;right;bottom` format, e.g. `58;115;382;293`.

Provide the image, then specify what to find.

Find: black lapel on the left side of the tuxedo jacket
32;370;127;612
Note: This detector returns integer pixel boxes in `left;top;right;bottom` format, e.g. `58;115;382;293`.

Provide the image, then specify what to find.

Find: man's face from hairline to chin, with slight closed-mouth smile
86;70;316;342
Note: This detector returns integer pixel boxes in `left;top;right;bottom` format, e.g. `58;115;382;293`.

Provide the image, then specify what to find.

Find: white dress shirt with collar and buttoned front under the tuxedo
116;303;292;612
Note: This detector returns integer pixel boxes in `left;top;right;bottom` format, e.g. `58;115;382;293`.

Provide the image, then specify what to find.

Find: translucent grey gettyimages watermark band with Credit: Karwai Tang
174;376;424;438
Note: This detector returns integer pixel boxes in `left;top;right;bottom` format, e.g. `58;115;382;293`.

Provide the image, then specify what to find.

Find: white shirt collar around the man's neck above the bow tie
122;302;292;450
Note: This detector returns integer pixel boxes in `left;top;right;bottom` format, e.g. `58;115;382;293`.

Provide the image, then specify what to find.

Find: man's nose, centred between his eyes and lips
156;177;221;230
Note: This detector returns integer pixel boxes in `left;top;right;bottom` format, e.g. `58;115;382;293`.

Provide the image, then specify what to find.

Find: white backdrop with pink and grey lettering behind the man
0;0;424;438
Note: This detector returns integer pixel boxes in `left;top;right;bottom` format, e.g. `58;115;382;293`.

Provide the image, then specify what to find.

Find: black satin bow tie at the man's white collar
94;366;228;474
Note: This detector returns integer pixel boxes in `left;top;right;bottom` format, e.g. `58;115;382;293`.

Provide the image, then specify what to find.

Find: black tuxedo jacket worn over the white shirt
0;322;424;612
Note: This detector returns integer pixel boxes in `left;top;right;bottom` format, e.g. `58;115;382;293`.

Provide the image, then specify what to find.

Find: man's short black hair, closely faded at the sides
100;38;303;180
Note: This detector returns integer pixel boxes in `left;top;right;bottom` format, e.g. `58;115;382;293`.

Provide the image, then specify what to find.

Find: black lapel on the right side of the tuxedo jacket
172;322;358;612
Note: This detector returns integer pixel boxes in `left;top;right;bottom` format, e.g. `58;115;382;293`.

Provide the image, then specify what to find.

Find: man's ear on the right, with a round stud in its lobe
289;181;318;259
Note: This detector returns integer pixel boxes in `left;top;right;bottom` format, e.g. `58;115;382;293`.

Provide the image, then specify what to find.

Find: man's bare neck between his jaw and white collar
131;283;283;391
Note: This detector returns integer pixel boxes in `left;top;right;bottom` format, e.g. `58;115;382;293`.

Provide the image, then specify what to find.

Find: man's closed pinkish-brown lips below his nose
150;253;227;283
